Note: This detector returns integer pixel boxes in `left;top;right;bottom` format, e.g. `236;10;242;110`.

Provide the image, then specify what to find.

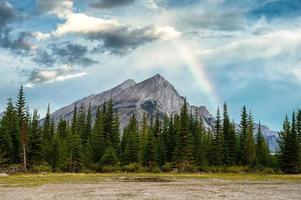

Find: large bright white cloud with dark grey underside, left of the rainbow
35;13;181;55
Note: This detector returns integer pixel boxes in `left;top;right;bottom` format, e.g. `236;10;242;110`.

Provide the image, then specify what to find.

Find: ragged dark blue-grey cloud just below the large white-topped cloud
33;42;98;67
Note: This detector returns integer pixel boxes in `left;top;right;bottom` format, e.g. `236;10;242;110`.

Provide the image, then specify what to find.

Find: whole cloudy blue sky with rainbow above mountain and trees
0;0;301;130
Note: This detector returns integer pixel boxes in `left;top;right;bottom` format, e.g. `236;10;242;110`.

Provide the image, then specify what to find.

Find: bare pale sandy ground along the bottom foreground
0;179;301;200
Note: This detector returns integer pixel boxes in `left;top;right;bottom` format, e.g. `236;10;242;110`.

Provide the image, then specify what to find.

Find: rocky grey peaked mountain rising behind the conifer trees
51;74;276;150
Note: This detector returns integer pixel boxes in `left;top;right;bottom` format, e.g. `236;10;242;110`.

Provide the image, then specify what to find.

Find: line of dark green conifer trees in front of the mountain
0;86;301;173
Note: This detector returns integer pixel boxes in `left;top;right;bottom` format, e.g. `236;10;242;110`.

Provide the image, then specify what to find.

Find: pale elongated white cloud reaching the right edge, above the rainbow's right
198;30;301;64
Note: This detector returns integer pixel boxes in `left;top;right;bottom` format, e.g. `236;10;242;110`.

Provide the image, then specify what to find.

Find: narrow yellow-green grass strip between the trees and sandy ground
0;173;301;187
